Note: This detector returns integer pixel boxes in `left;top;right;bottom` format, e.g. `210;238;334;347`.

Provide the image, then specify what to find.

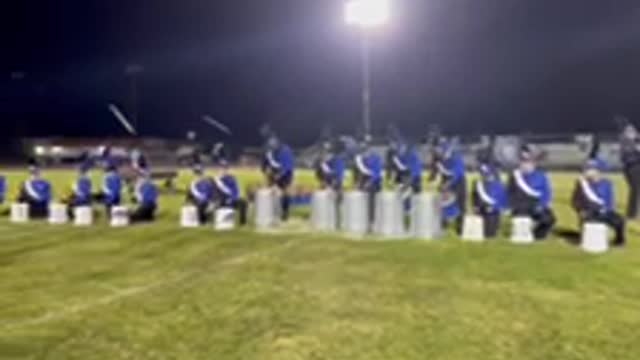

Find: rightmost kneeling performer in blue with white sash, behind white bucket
571;158;626;246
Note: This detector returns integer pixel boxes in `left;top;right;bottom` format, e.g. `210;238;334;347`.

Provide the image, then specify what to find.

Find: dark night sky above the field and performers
0;0;640;144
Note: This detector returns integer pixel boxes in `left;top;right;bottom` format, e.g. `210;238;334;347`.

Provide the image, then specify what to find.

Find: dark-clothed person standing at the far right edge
620;123;640;219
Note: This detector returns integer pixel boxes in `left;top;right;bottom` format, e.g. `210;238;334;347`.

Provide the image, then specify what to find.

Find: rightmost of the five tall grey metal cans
411;192;442;240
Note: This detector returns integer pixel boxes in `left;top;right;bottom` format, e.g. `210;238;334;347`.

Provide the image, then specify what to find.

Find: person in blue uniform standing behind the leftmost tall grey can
262;135;295;221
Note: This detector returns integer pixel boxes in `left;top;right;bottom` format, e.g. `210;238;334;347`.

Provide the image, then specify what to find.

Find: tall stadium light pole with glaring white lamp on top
345;0;391;134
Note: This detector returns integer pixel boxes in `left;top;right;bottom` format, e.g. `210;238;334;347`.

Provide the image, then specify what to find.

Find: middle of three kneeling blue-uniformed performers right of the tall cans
507;145;556;240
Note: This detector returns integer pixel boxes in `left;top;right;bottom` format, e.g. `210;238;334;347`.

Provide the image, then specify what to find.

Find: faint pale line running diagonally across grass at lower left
0;240;297;331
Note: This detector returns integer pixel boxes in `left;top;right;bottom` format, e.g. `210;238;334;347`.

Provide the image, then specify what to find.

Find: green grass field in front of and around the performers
0;172;640;360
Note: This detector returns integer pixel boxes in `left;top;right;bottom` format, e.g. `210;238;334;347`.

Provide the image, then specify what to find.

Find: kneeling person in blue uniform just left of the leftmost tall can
213;160;248;225
